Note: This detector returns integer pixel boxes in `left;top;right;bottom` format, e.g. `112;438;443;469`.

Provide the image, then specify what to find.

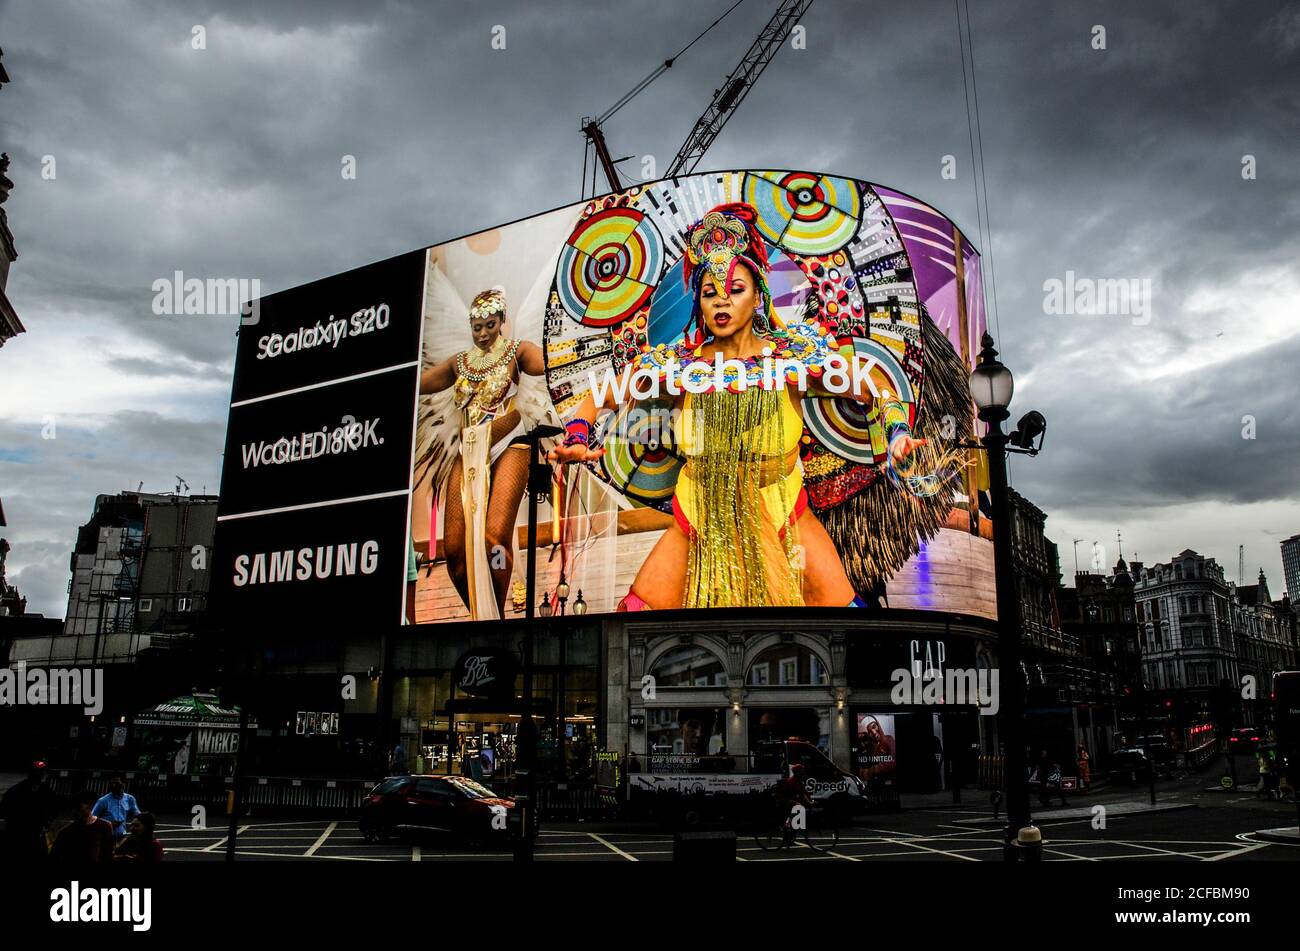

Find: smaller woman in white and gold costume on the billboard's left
411;290;554;620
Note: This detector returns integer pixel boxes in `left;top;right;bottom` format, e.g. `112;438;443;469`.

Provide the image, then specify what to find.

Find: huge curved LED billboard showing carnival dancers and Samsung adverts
217;170;995;624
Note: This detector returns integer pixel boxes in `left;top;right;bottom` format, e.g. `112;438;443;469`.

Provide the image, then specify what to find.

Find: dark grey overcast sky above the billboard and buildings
0;0;1300;617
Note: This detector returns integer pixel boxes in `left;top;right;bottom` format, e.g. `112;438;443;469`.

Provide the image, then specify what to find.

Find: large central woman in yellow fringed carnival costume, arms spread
550;203;926;611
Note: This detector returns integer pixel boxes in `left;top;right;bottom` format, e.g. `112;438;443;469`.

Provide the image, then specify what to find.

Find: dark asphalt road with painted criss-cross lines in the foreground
159;780;1300;861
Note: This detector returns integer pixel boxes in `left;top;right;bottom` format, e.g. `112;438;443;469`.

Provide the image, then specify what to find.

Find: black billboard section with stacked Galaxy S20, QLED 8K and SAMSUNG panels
213;252;424;628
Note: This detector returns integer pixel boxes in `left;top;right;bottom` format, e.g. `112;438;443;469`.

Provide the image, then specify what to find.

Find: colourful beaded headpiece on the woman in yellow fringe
681;201;781;343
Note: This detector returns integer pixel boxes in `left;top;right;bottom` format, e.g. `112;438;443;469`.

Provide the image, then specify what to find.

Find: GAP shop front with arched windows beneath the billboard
610;621;996;804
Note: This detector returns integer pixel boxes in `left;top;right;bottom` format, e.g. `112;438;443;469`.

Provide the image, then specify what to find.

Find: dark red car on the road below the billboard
360;776;515;842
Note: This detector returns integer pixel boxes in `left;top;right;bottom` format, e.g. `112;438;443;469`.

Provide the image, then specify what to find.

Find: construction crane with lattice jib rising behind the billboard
581;0;813;194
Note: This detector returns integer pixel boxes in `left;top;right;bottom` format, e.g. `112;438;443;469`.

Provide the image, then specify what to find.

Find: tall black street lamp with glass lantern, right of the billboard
970;331;1047;861
